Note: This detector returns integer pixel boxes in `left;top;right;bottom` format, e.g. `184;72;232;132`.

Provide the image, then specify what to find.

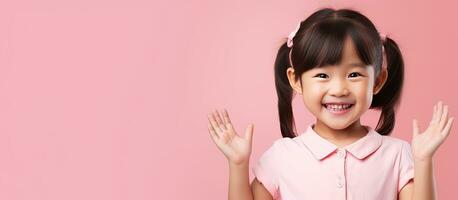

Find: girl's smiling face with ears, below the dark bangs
287;38;387;130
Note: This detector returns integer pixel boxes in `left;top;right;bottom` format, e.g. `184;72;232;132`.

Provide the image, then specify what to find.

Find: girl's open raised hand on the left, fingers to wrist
208;109;254;165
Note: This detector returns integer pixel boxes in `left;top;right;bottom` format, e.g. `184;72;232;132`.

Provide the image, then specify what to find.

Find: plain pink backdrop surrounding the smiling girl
0;0;458;200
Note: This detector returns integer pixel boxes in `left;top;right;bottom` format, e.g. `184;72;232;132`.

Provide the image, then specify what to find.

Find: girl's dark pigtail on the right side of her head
371;37;404;135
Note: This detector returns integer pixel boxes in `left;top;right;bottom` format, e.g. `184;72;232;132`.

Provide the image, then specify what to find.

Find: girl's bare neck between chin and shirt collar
313;119;368;146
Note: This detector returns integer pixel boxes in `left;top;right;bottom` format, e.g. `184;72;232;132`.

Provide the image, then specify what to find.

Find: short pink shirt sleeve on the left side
252;141;280;199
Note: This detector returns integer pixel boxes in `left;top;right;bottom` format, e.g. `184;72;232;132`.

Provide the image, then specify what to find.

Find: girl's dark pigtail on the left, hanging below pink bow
274;42;296;138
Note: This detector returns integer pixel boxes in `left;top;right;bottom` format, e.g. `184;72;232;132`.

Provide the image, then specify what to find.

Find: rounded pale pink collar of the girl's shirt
299;125;382;160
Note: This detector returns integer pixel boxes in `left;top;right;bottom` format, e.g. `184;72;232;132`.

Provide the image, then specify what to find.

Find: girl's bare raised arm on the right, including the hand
399;101;453;200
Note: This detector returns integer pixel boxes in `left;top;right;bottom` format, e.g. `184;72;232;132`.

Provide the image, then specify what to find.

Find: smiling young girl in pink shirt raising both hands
208;8;453;200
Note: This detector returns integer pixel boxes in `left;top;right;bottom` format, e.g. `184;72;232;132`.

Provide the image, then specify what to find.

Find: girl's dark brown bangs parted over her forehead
292;18;381;71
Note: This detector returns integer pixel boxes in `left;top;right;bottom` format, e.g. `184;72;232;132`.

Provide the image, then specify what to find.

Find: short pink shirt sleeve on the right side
398;141;414;193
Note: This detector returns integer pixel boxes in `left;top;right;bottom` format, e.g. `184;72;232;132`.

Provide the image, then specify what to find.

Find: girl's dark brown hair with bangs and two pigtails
274;8;404;138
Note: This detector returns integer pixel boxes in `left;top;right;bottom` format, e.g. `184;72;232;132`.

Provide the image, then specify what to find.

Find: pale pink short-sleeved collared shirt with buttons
252;125;414;200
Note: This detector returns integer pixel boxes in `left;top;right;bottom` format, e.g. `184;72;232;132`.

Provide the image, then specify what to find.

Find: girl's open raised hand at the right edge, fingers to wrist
412;101;453;160
